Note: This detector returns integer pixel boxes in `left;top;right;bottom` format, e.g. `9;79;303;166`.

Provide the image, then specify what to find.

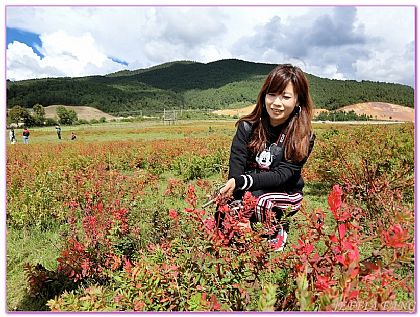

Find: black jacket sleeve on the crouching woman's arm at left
228;121;251;179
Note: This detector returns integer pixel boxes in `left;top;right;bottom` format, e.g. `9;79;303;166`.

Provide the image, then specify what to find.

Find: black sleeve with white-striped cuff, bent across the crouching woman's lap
234;131;315;191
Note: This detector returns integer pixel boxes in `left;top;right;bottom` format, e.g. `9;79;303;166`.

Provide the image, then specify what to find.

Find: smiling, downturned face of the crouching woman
265;82;297;127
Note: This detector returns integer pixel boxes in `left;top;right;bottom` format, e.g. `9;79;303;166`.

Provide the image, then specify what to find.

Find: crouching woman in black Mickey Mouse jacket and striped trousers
216;64;315;250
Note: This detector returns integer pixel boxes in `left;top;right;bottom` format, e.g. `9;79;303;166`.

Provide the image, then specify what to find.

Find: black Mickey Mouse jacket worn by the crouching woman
229;121;315;199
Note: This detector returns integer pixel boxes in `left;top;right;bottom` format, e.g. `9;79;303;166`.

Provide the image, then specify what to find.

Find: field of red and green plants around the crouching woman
6;121;415;312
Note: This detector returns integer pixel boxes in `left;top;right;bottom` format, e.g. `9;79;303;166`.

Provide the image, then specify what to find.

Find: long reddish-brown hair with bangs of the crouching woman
236;64;313;162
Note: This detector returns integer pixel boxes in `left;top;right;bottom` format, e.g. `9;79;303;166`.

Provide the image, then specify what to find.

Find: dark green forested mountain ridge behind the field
7;59;414;114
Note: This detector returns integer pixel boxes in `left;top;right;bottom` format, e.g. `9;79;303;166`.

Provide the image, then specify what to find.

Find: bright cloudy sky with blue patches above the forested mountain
6;6;415;86
